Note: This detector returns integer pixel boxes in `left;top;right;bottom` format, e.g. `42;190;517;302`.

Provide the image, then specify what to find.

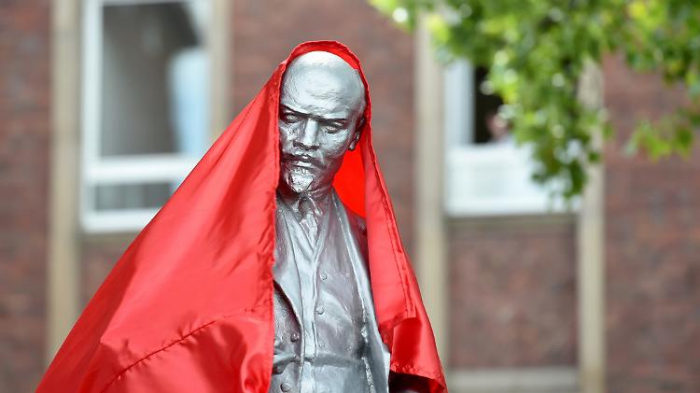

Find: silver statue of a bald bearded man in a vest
270;52;389;393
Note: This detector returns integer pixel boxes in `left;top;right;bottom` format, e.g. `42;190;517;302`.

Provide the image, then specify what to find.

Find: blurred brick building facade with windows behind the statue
0;0;700;393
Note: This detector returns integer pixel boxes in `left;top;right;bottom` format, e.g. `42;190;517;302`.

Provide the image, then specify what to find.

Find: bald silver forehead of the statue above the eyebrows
280;54;365;118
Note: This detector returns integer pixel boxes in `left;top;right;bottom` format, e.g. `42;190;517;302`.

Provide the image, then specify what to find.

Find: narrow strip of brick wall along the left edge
0;0;50;392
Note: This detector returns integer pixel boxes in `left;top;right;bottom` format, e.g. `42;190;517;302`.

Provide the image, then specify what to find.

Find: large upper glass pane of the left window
100;1;209;156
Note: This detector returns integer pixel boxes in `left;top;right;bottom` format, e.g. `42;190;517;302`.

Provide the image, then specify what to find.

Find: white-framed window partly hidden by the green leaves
444;61;561;216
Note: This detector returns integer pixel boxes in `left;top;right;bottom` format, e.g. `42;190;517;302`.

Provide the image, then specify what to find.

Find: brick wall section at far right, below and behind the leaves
604;58;700;393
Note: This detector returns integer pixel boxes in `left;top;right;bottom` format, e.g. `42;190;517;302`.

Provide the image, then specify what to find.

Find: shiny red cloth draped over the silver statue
37;41;446;393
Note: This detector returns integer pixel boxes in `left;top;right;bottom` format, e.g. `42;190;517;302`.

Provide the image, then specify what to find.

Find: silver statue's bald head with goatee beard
279;52;365;194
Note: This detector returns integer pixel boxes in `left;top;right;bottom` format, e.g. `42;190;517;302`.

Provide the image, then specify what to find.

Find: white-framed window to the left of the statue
80;0;210;232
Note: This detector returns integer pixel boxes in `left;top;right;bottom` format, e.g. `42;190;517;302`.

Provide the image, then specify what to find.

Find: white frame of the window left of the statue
79;0;208;233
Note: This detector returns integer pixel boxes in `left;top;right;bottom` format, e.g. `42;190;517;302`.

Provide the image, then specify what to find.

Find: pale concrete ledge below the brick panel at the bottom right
448;367;578;393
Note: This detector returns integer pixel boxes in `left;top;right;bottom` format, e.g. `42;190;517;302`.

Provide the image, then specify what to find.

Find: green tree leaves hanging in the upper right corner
370;0;700;198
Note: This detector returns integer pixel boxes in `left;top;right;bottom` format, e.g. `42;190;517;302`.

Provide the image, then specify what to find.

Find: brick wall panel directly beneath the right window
448;216;577;369
